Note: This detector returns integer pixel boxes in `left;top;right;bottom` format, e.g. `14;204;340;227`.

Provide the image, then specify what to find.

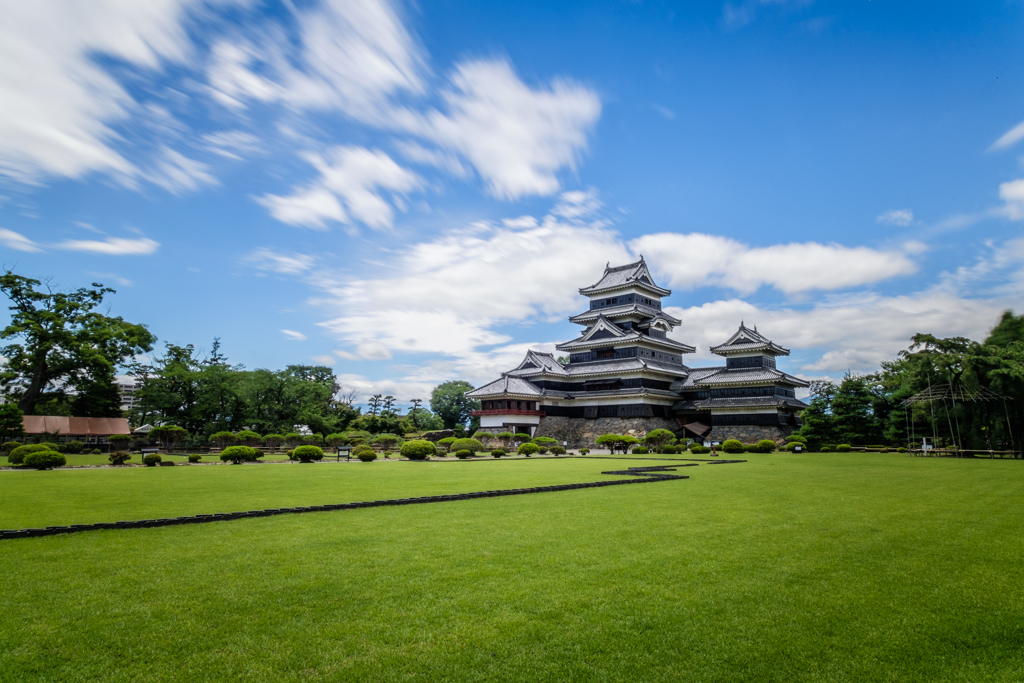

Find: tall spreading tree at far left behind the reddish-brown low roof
0;270;157;417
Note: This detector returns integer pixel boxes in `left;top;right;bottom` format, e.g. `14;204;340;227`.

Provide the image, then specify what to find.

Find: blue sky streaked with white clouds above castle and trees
0;0;1024;400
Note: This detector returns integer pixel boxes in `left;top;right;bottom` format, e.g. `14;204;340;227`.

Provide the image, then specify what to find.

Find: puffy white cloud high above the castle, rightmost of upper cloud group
393;60;601;200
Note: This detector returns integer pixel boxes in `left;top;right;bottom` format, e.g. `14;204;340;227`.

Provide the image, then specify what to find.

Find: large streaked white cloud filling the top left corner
0;0;242;182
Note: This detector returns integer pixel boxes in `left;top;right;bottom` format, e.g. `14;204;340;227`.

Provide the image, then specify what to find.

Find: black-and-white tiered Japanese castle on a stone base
466;256;808;446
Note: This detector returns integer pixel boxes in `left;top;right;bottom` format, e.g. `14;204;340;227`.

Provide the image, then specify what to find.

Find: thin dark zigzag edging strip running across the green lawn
0;460;744;541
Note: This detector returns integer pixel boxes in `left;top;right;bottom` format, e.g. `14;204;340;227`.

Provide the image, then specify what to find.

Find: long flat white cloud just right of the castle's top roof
630;232;919;294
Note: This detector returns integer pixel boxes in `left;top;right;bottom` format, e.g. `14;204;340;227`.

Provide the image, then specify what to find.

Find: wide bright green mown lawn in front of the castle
0;454;1024;682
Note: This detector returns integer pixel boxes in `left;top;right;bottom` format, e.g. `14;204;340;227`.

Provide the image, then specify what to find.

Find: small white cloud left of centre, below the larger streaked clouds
258;146;422;229
